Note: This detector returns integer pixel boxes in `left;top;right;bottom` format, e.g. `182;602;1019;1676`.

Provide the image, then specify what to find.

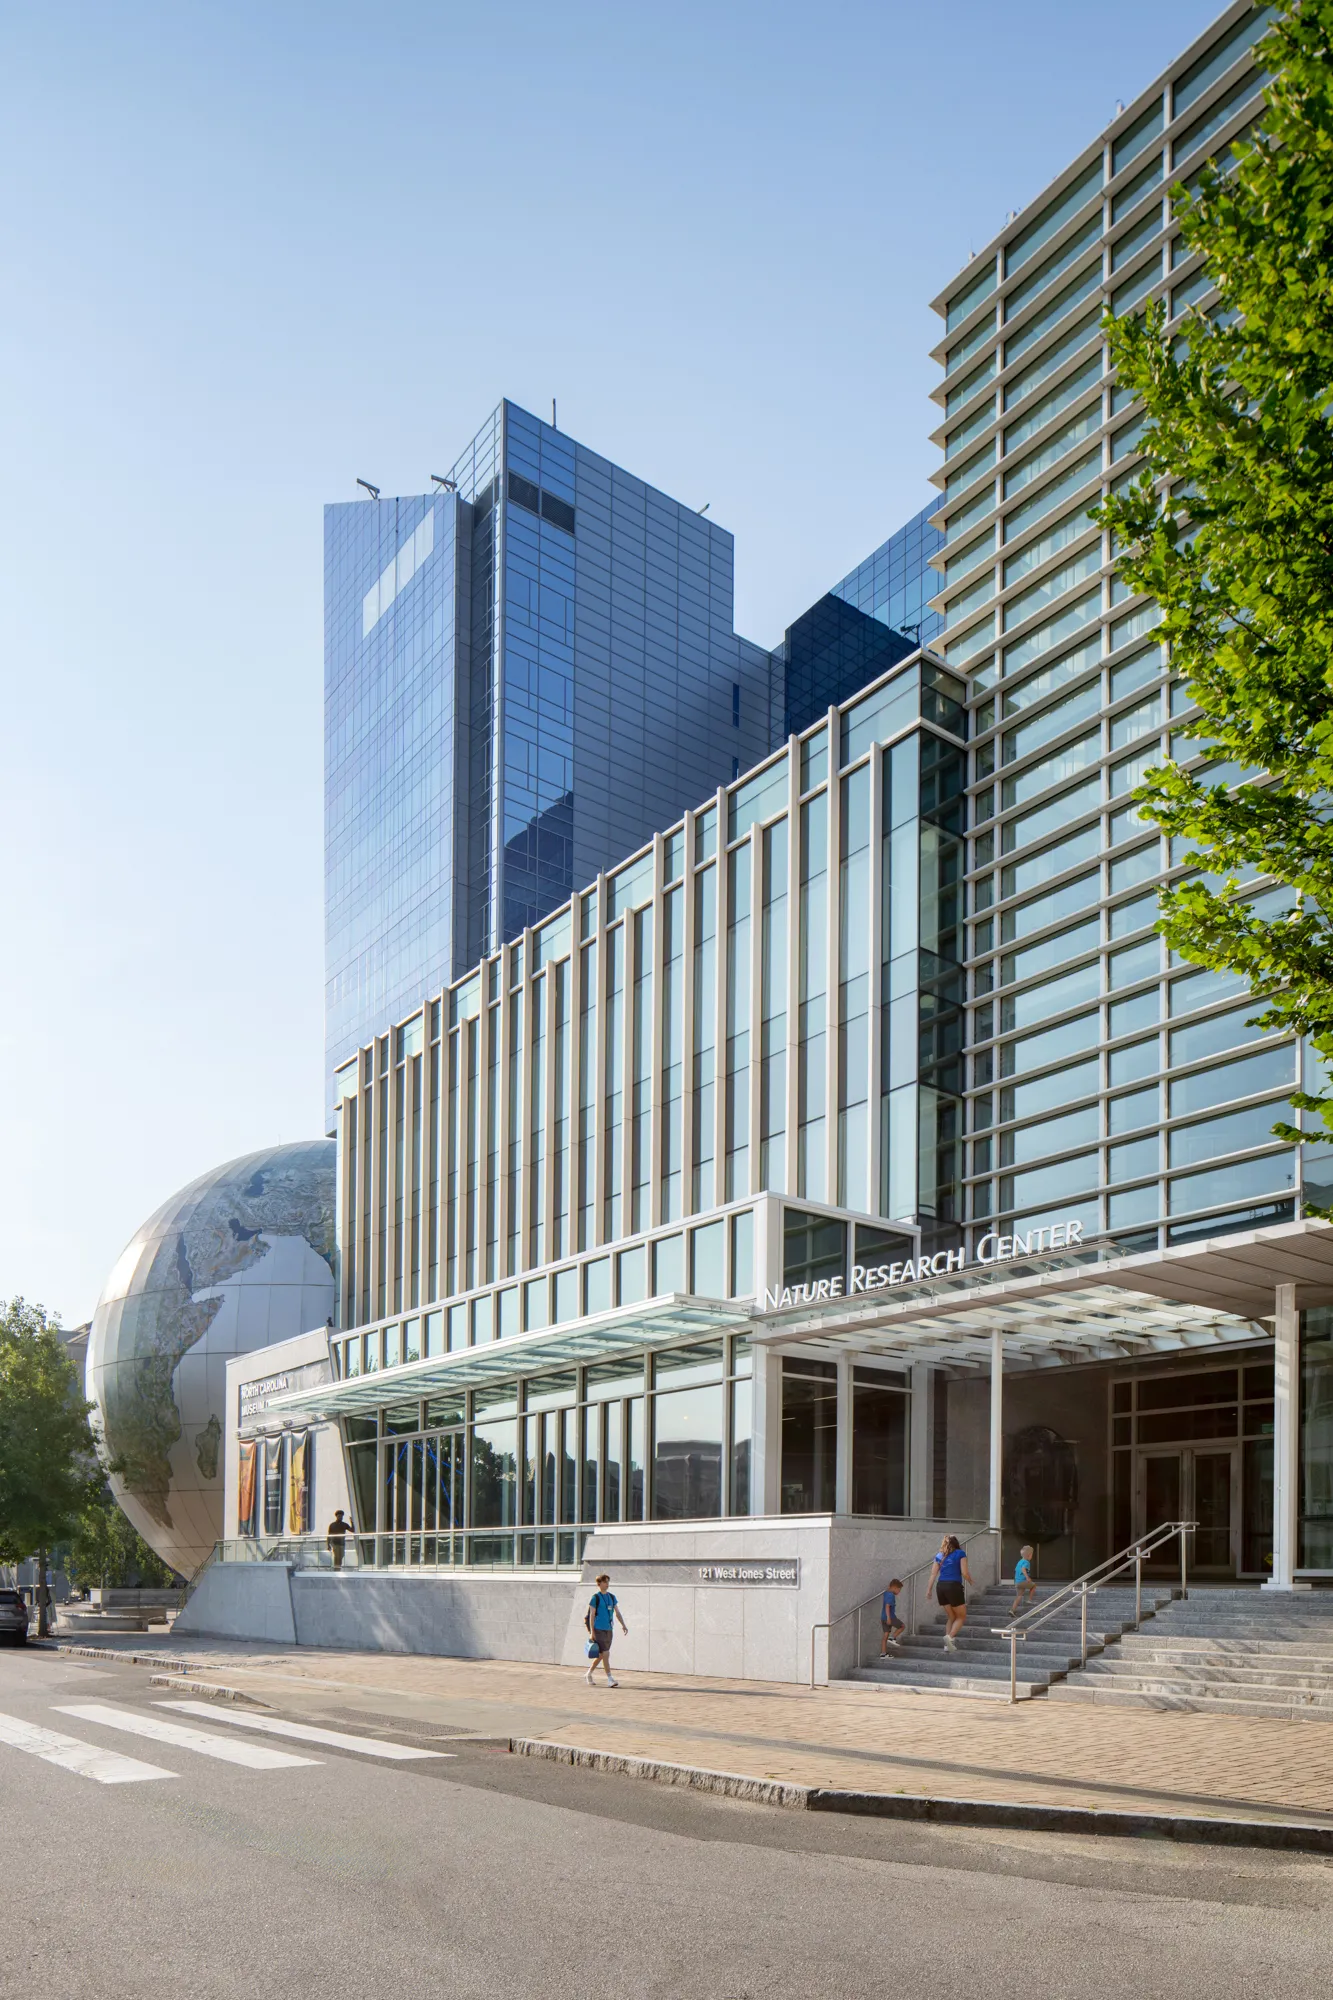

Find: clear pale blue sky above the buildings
0;0;1219;1324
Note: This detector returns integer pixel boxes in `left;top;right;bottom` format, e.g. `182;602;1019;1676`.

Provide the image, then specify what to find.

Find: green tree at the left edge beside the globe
0;1298;100;1562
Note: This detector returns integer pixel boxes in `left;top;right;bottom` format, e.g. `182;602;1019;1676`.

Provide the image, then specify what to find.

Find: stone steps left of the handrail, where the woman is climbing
847;1582;1173;1700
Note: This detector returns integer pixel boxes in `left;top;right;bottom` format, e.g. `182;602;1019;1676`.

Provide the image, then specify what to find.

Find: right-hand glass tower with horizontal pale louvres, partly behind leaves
920;4;1288;1242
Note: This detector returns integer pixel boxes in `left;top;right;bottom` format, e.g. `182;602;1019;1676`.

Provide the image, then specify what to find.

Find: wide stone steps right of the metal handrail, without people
1051;1584;1333;1722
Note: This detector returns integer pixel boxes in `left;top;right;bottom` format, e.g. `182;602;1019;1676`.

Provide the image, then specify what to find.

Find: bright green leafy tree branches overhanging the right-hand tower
1097;0;1333;1184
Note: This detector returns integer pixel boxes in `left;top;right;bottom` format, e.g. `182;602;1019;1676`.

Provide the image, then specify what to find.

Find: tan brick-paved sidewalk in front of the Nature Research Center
46;1634;1333;1826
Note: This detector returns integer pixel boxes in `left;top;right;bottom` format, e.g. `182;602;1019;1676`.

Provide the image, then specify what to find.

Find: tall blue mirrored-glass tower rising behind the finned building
324;402;781;1104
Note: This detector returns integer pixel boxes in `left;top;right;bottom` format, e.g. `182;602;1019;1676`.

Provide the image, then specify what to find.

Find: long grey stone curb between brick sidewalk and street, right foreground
508;1736;1333;1854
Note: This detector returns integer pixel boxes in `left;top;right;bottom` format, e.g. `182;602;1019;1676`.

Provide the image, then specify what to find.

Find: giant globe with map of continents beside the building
86;1140;336;1576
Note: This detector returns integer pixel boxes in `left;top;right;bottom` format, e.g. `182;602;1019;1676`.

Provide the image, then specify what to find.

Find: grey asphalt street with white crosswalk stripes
0;1650;1333;2000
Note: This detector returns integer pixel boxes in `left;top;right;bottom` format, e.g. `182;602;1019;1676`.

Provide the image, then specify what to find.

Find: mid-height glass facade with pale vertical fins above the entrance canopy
336;656;965;1346
